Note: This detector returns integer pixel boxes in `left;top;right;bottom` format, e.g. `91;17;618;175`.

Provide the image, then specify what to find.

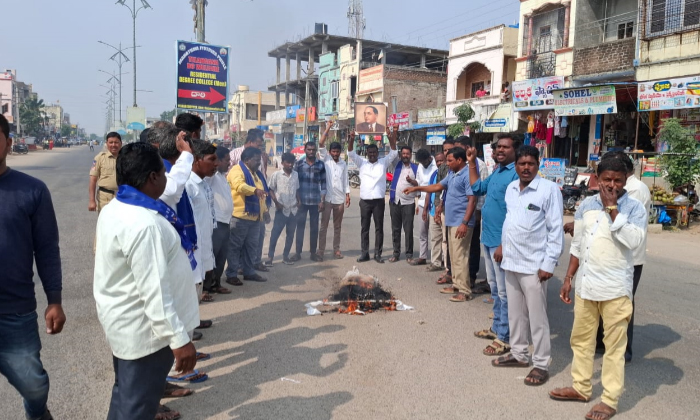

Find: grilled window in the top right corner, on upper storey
646;0;700;36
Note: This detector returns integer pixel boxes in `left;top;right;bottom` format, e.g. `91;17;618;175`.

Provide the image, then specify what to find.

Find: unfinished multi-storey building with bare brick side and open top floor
268;29;448;144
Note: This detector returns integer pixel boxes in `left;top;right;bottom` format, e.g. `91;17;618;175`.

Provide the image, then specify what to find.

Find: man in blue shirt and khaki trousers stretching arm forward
405;147;476;302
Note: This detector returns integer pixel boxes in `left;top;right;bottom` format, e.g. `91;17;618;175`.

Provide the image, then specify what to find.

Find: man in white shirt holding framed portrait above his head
348;125;399;263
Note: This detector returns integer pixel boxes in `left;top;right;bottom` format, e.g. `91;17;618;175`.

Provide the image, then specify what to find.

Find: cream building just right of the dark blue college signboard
230;85;284;141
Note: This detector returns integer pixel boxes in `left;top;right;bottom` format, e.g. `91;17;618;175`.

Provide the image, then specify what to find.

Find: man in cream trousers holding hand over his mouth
549;158;647;420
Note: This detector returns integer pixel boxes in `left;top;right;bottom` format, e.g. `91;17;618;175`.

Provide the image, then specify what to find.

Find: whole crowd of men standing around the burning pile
0;108;650;420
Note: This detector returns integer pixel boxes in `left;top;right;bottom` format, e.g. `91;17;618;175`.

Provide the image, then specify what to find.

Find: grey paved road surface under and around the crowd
0;147;700;420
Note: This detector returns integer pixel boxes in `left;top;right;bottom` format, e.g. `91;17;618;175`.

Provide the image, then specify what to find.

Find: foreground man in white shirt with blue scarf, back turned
93;143;199;420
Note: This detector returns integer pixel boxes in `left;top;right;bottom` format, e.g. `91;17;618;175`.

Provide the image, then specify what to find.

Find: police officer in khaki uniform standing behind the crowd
88;132;122;213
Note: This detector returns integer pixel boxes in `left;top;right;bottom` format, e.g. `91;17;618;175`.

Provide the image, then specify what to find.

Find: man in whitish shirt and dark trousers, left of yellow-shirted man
204;146;233;294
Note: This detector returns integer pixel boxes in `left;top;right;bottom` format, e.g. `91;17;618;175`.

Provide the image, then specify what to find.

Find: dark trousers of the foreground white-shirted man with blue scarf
107;347;175;420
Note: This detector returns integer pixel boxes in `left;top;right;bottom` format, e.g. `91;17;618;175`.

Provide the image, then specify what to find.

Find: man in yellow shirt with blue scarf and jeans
226;147;270;286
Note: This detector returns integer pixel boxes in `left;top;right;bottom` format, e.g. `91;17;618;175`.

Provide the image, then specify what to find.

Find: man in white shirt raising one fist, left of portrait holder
318;121;350;260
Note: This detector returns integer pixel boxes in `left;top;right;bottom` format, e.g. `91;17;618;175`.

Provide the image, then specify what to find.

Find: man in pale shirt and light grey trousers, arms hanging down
491;146;564;385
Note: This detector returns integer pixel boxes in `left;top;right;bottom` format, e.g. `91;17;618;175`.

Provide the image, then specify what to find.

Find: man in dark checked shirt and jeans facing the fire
289;141;326;262
